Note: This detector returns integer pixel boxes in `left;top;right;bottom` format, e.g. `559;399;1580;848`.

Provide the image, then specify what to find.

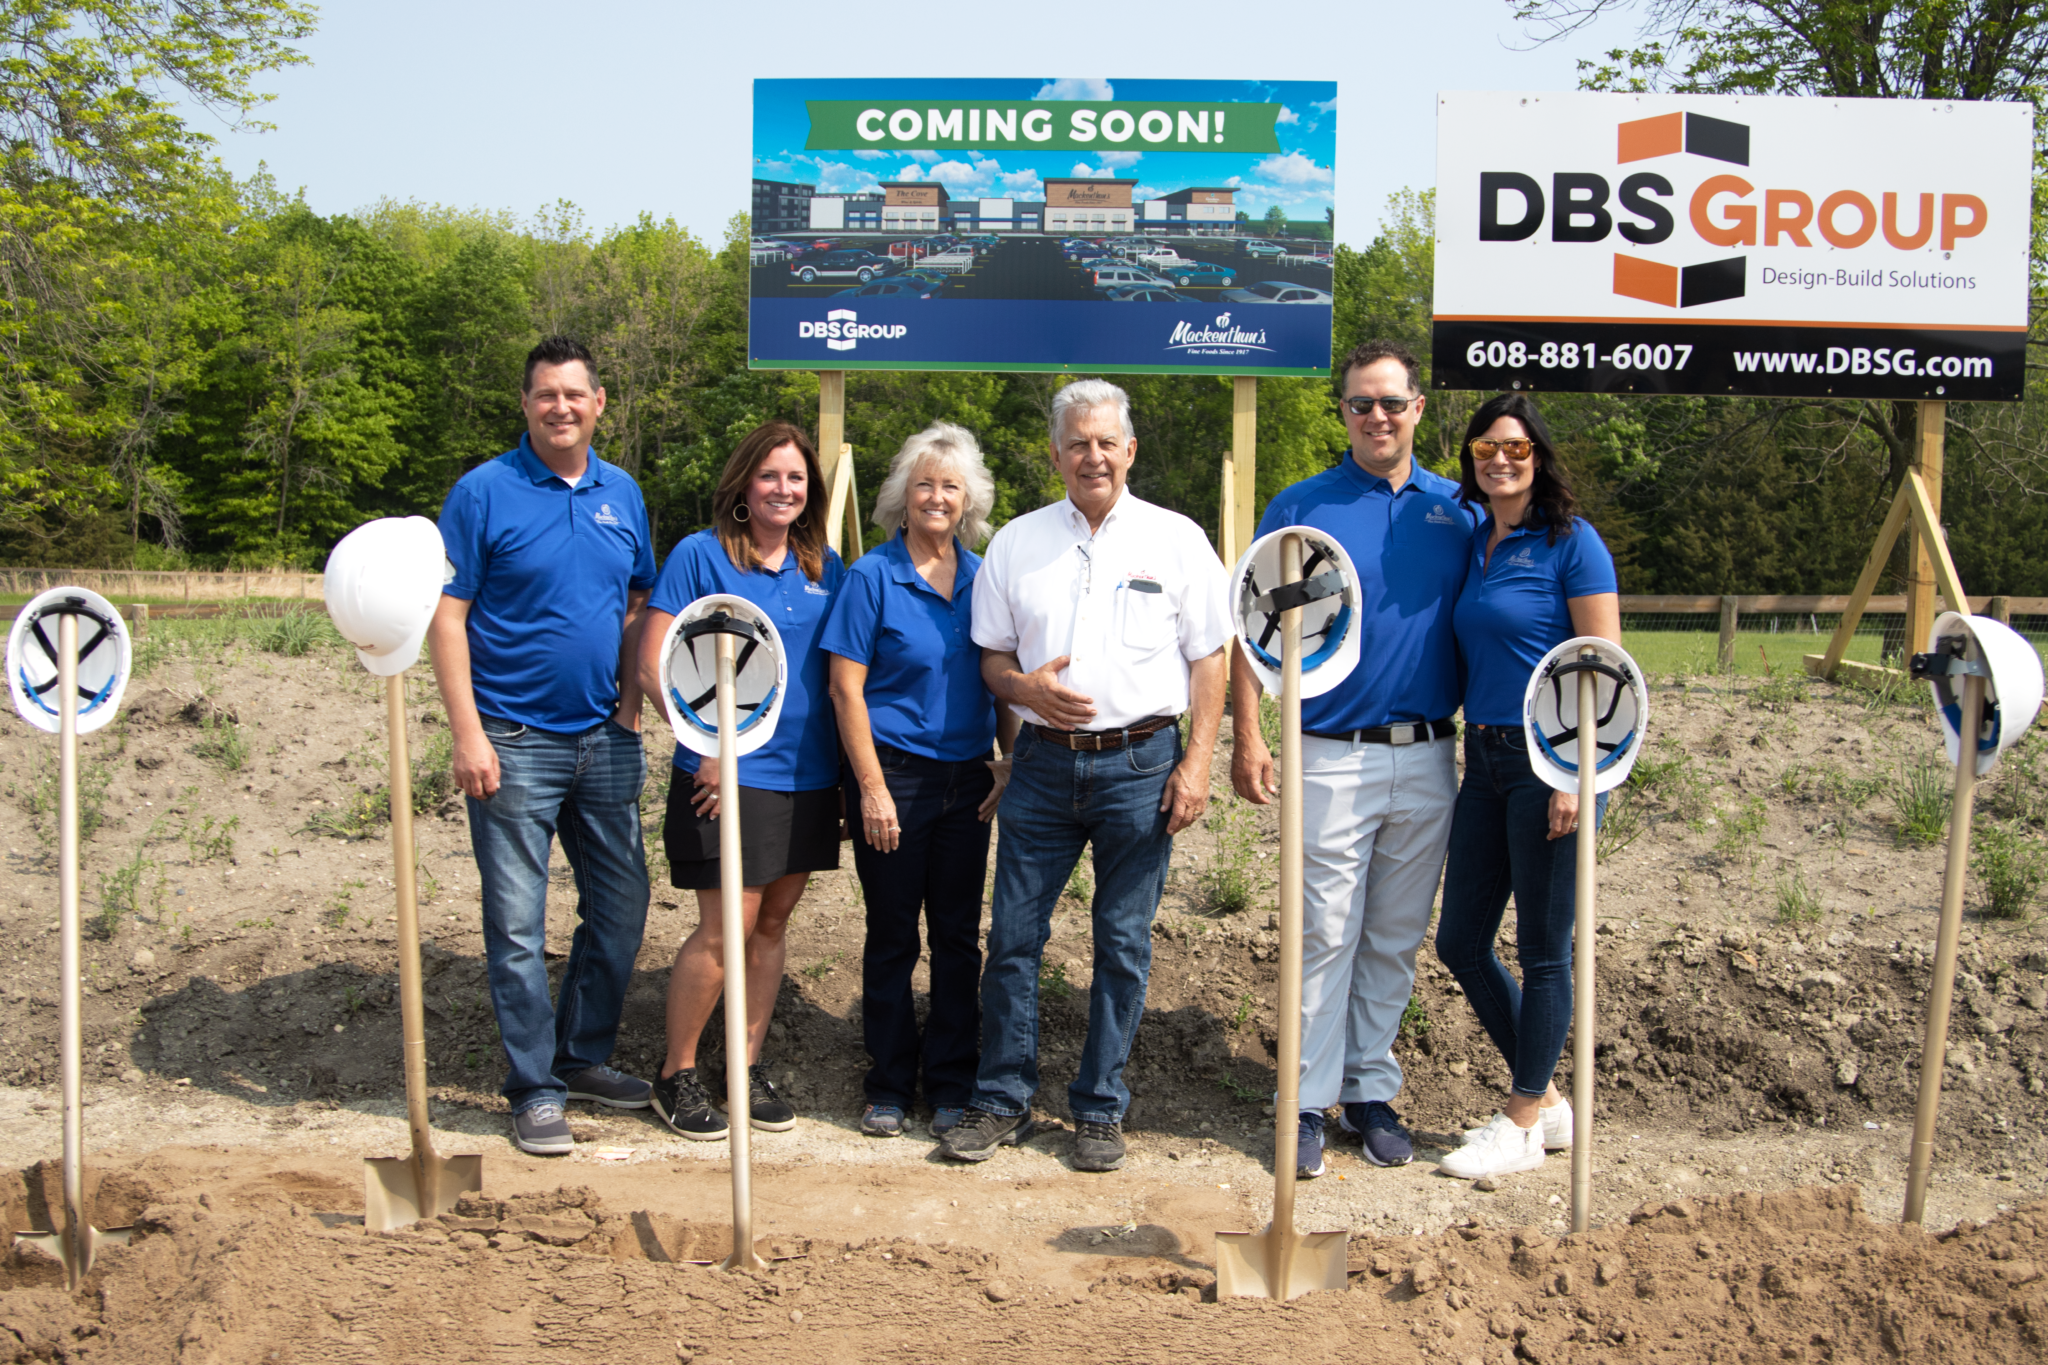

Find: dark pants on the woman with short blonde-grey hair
846;743;995;1109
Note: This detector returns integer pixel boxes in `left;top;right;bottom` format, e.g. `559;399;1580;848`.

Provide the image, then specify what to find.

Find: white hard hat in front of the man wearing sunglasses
1231;526;1360;698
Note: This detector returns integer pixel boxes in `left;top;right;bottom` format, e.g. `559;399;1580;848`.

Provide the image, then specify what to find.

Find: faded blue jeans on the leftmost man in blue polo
469;716;647;1113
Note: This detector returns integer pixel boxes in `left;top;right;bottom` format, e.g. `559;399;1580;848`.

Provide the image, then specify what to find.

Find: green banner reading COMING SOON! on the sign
805;100;1280;151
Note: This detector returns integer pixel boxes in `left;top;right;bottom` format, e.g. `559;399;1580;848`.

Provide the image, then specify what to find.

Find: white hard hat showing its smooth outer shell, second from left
319;516;449;677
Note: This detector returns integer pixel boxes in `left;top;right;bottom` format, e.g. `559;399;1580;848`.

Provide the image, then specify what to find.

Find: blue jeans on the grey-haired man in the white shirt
973;724;1180;1124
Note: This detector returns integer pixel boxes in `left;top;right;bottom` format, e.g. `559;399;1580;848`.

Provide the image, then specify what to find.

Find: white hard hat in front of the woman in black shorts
662;593;788;759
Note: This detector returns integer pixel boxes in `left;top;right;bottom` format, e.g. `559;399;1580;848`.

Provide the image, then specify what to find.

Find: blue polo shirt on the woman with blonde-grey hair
823;532;995;763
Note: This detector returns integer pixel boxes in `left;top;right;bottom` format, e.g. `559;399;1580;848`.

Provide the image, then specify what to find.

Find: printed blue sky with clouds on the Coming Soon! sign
754;78;1337;221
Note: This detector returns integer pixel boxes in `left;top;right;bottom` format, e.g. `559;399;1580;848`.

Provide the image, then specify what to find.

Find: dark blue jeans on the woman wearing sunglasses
1436;724;1608;1097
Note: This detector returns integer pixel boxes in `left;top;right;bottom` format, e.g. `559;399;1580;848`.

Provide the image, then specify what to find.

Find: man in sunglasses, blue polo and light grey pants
1231;342;1473;1177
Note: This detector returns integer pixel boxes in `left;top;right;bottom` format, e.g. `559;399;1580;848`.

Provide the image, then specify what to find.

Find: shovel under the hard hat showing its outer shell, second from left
362;673;483;1232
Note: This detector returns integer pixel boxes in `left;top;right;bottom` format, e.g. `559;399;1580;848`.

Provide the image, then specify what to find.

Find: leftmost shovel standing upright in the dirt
14;612;135;1291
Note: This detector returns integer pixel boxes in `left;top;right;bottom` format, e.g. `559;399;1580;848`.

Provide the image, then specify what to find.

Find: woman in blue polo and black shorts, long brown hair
639;422;846;1140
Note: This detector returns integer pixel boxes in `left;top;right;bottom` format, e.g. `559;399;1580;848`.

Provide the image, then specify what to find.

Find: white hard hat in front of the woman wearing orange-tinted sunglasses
1522;634;1651;792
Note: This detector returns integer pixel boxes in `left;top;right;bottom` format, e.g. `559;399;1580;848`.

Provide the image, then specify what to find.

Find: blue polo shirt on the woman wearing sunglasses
1456;516;1620;724
